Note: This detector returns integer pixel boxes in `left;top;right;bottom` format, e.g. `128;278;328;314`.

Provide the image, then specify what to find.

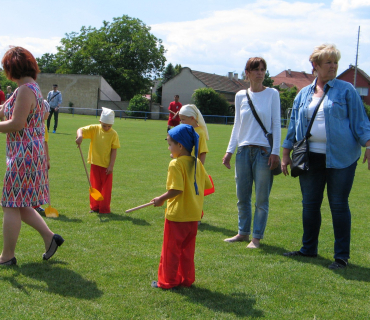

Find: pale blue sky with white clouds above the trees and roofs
0;0;370;75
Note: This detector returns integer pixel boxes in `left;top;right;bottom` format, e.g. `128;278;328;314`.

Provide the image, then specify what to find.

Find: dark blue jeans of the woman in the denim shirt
299;152;357;260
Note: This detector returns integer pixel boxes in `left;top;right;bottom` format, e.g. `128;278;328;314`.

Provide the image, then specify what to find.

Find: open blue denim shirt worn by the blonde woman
283;79;370;169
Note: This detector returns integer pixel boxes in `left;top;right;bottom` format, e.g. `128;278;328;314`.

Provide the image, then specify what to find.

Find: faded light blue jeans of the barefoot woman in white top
235;146;273;239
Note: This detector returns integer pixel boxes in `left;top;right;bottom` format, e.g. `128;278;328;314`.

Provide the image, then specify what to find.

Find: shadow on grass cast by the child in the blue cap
173;285;264;318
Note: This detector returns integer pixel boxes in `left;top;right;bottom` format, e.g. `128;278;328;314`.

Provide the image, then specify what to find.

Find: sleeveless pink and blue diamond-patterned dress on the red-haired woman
1;83;49;208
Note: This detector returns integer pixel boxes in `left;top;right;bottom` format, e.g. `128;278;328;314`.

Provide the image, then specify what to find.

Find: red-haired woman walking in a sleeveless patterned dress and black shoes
0;47;64;265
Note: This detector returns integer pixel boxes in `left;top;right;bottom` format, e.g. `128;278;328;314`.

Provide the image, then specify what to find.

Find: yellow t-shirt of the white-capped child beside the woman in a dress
81;124;120;168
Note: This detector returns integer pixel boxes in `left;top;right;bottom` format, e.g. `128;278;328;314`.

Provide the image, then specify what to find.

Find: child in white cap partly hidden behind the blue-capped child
179;104;209;165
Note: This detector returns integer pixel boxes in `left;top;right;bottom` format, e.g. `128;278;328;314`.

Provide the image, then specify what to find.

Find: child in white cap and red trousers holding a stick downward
76;107;120;214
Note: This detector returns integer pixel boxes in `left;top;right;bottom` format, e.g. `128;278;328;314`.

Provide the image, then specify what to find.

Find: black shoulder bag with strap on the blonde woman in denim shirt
290;85;330;178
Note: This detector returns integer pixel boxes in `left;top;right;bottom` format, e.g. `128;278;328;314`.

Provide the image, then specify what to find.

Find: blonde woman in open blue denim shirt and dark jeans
281;44;370;269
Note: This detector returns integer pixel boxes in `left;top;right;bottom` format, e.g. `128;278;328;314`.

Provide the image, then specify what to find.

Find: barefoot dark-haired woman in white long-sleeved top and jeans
222;57;281;249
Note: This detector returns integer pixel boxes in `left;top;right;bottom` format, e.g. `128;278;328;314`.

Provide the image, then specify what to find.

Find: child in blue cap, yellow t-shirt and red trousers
152;124;212;289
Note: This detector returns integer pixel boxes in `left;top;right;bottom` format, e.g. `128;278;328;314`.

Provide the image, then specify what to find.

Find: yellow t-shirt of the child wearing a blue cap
166;156;212;222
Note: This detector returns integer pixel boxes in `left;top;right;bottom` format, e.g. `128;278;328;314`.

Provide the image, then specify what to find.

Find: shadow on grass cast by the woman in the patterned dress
3;261;103;300
